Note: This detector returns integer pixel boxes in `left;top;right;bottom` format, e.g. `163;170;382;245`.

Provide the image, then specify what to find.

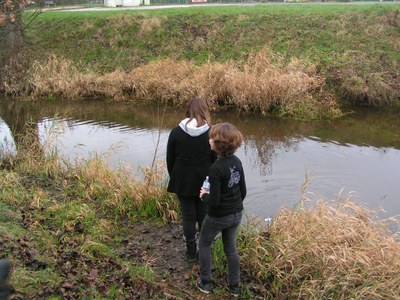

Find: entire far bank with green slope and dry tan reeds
2;4;400;119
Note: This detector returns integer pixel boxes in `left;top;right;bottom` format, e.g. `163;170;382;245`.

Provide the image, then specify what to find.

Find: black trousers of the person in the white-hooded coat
178;195;207;241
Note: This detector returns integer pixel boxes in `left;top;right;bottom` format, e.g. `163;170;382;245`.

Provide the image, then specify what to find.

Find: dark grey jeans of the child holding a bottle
199;212;242;285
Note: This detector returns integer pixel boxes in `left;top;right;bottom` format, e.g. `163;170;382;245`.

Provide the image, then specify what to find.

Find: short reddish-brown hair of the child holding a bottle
210;123;243;156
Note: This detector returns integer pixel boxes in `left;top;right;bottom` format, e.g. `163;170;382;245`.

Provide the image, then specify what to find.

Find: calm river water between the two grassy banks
0;99;400;223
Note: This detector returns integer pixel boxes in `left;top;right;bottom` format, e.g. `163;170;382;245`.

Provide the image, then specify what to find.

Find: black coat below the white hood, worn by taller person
167;126;216;196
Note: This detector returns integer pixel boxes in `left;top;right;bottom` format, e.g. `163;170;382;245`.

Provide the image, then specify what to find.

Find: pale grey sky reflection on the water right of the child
241;137;400;223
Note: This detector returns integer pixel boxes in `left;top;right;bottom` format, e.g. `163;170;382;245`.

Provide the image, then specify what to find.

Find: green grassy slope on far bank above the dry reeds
7;3;400;119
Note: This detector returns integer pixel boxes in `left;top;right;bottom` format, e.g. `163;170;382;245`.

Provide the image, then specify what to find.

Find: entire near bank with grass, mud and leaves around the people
0;132;400;299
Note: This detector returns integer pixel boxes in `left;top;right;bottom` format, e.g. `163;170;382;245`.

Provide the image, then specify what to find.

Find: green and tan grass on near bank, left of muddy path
0;141;177;299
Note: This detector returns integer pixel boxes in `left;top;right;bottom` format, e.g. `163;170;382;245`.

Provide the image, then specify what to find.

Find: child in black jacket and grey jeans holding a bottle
197;123;246;297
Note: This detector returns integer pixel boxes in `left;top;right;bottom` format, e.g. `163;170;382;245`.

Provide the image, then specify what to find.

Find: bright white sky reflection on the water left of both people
38;118;168;175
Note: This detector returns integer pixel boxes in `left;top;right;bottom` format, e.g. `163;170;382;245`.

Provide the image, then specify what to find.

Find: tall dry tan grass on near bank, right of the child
241;200;400;299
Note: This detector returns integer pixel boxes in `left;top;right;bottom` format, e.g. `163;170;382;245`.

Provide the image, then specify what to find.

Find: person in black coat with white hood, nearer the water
167;98;216;262
